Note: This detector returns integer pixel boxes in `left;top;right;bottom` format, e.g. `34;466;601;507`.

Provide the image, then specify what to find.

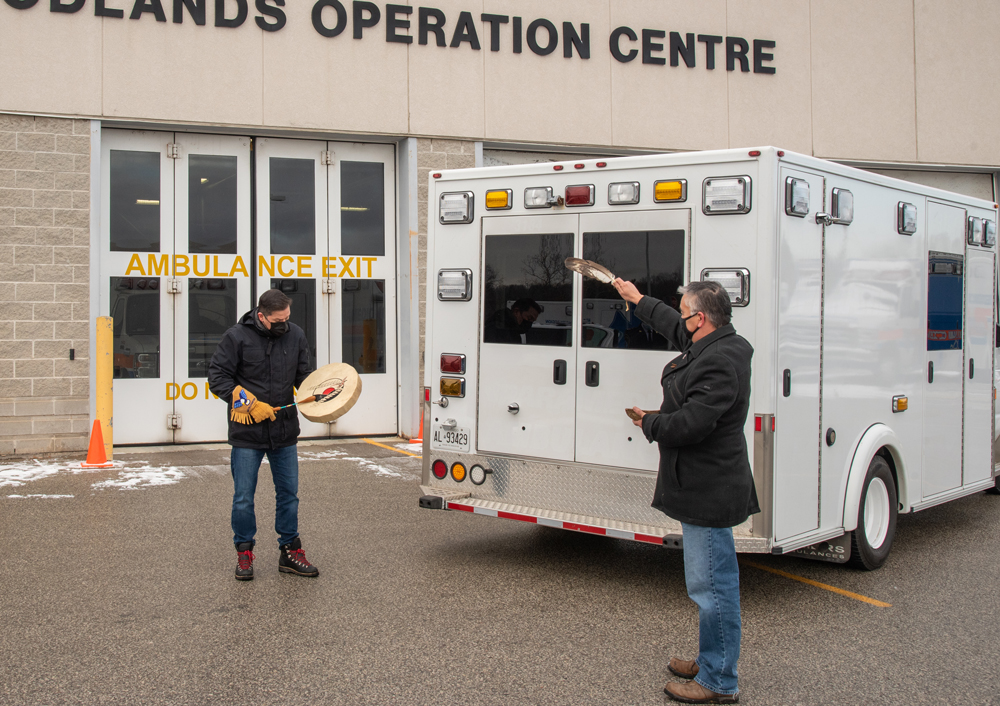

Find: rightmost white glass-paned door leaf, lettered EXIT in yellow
321;142;399;436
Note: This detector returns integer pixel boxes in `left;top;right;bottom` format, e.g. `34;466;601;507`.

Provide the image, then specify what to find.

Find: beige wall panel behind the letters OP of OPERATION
264;0;410;134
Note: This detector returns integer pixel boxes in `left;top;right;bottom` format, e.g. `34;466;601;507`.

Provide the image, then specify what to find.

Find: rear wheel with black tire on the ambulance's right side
850;456;899;571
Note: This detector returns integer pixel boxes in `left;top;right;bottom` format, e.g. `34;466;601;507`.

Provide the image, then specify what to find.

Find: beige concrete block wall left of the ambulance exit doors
0;114;90;456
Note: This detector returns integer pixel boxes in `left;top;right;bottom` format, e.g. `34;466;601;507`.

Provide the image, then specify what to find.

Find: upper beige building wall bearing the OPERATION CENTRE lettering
0;0;1000;166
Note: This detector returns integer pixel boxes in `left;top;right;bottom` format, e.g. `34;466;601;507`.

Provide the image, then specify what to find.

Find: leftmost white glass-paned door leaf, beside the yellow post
98;130;174;443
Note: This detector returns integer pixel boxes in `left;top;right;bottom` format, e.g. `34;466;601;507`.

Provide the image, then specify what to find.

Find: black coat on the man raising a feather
636;297;760;527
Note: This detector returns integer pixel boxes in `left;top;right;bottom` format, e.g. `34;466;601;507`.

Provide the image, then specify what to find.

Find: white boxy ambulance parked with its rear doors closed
420;147;1000;569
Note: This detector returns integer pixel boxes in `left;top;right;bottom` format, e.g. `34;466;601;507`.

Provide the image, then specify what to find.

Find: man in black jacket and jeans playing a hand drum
208;289;319;581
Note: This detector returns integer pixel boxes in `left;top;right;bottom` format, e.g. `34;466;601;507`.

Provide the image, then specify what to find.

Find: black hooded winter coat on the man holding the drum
208;308;312;449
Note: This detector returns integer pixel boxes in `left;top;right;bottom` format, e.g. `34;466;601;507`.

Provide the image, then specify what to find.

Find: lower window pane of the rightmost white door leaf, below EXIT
341;279;385;373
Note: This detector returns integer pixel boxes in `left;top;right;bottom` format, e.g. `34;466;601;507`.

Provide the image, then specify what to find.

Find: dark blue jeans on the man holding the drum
229;446;299;546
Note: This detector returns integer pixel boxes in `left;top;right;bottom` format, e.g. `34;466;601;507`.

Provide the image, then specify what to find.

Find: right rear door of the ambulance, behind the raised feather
575;209;691;471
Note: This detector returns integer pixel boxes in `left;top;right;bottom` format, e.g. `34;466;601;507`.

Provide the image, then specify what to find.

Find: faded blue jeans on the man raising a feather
683;524;742;694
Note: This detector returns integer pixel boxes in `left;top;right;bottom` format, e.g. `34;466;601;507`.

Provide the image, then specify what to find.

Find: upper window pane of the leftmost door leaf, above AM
108;150;160;252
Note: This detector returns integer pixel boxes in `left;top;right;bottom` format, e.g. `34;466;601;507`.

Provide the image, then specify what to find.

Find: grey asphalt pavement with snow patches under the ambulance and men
0;439;1000;706
